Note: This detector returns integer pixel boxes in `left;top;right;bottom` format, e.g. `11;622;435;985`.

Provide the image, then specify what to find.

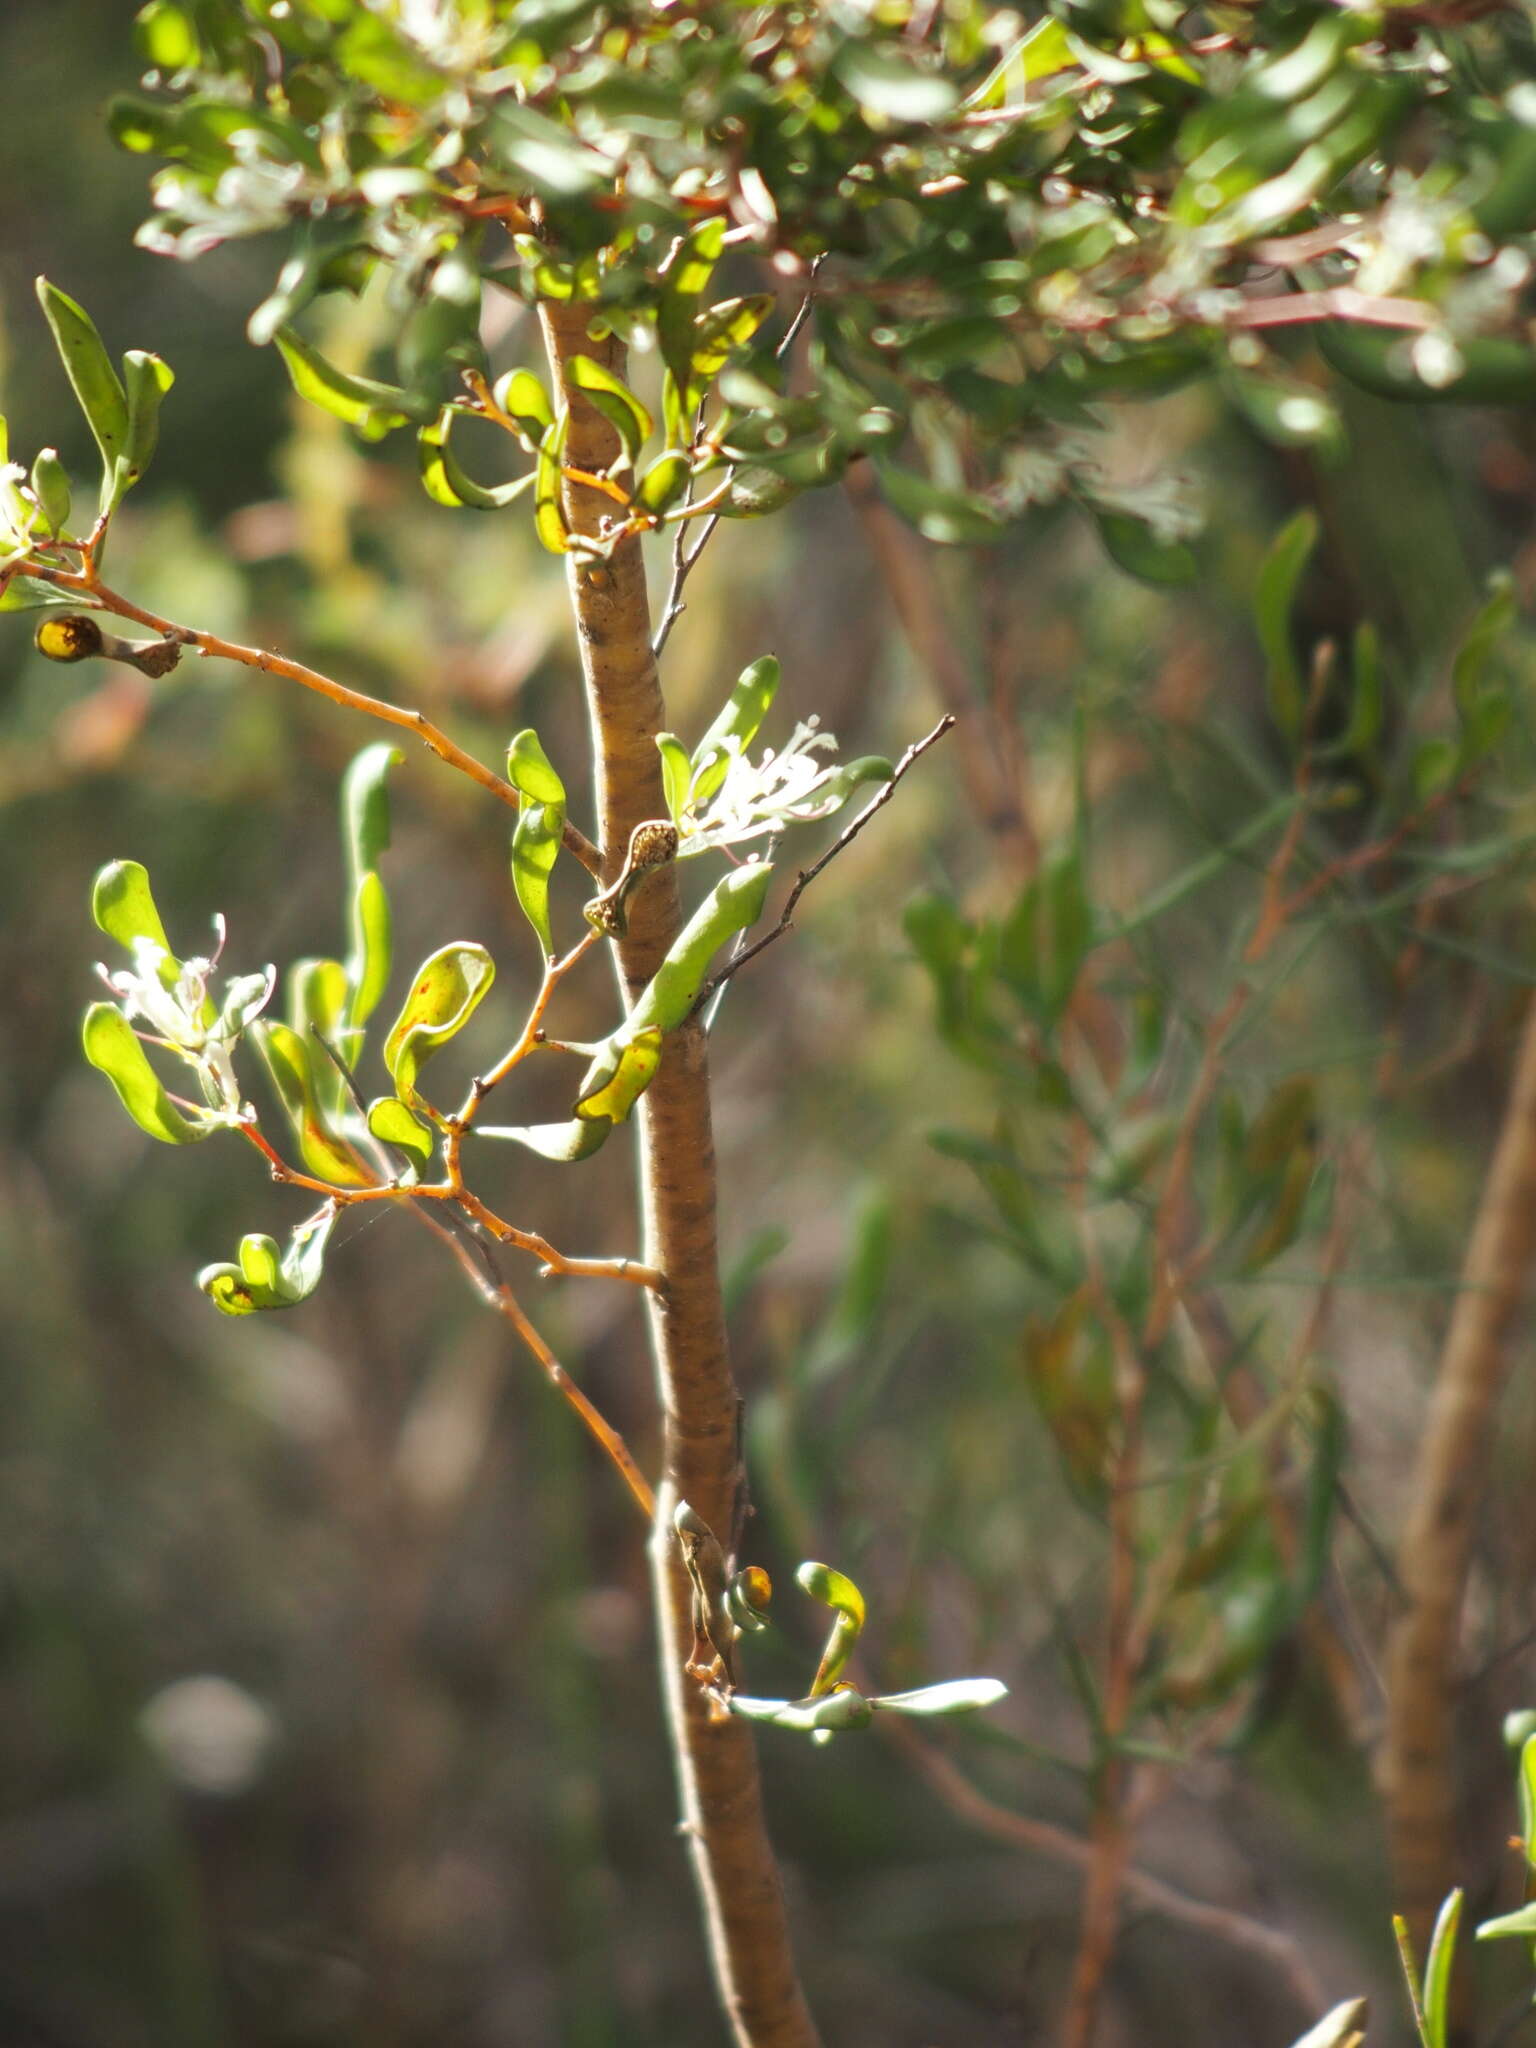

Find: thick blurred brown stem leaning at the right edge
1382;1004;1536;1952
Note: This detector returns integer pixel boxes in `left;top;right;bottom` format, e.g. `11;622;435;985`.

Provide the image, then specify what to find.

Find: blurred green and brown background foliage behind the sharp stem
15;0;1536;2048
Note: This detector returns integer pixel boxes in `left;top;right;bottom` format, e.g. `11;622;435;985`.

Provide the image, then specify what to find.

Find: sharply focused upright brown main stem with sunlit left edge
541;303;831;2048
